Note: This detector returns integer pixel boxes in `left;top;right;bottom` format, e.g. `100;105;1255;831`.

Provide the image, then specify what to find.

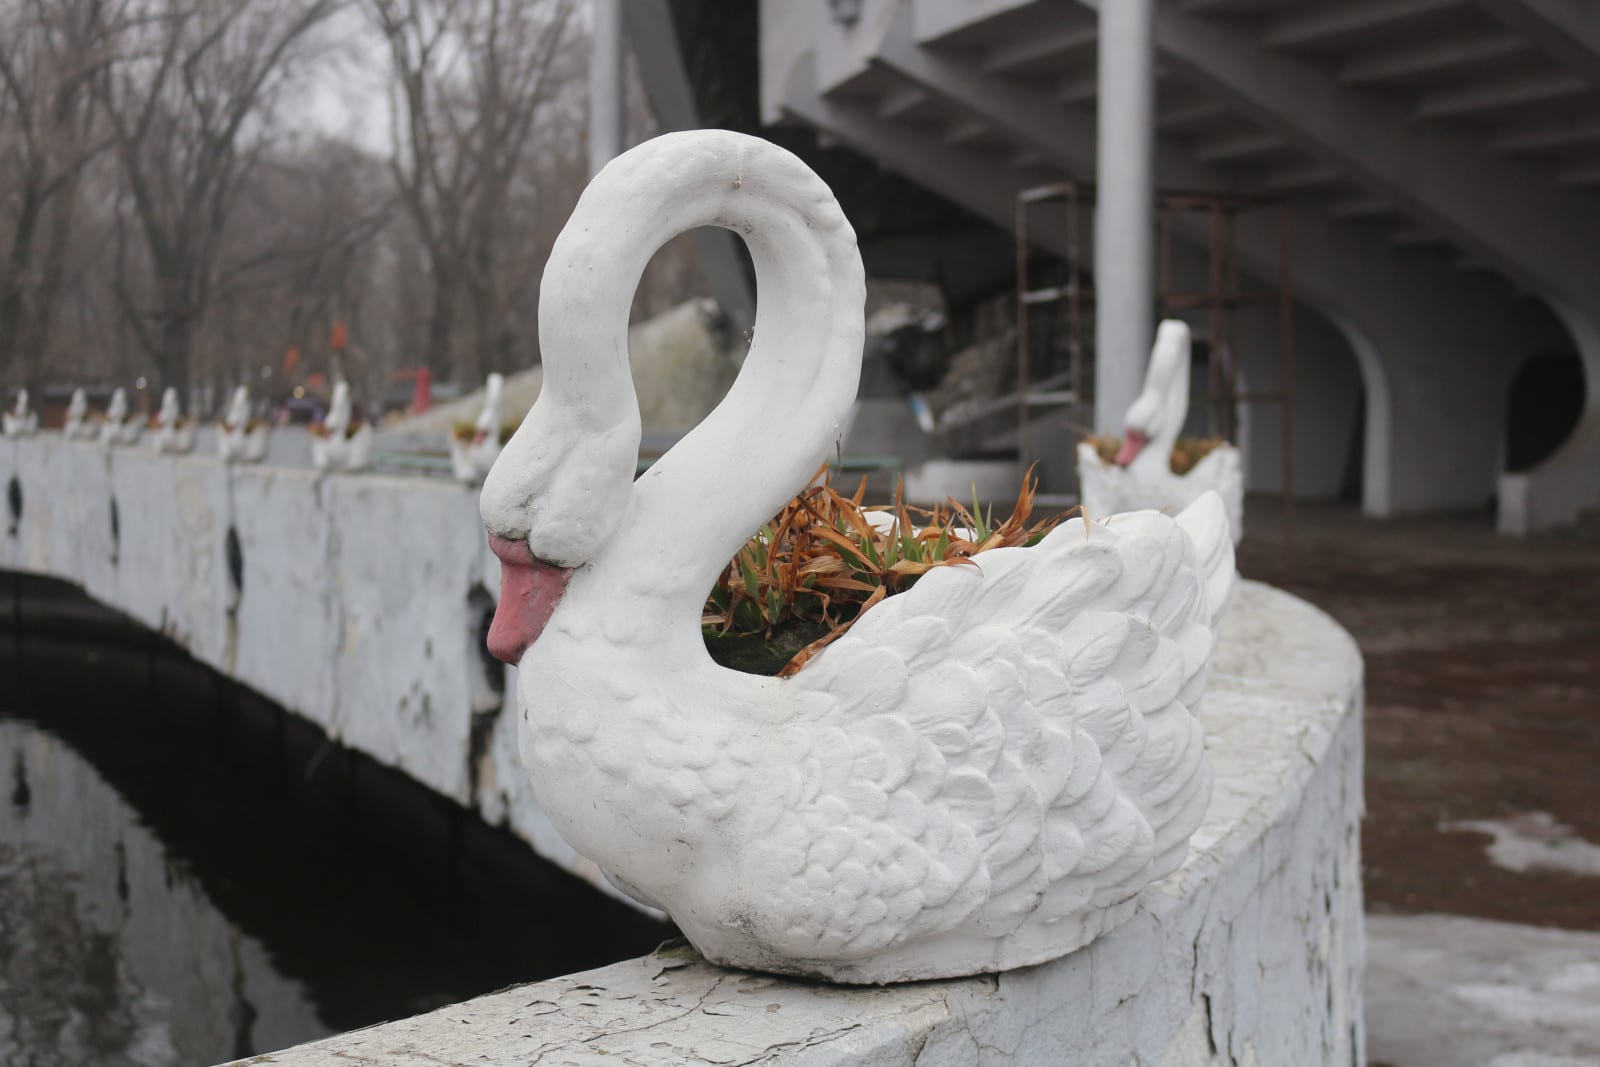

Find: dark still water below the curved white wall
0;576;670;1067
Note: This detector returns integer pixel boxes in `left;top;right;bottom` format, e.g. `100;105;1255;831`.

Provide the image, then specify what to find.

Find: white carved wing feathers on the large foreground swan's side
747;494;1234;958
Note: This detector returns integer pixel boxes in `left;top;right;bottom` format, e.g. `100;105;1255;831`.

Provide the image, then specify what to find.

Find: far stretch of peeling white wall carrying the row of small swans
0;434;611;891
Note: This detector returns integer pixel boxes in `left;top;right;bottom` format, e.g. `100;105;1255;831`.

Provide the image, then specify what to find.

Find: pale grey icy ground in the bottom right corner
1366;915;1600;1067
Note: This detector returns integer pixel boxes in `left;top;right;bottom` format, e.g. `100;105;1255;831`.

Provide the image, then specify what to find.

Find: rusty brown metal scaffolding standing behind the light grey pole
1016;182;1294;549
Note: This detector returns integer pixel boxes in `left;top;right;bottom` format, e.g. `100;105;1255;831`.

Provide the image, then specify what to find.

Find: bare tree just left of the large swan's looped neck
366;0;581;379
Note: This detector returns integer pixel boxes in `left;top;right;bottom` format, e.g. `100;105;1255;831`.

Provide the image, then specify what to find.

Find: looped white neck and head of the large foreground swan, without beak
499;131;866;641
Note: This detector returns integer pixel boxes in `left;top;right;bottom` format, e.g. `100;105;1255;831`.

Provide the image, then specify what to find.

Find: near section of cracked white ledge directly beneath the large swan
222;584;1365;1067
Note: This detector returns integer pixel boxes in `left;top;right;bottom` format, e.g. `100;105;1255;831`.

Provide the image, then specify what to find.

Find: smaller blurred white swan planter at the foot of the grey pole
1078;318;1245;544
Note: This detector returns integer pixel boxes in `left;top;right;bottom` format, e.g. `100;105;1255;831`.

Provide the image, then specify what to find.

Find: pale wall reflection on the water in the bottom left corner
0;720;318;1067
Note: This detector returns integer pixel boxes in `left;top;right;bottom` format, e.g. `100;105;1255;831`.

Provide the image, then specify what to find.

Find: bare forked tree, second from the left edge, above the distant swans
98;0;338;396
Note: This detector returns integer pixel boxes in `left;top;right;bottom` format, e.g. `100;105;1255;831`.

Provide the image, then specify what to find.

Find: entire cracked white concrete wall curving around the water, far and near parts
0;435;1365;1067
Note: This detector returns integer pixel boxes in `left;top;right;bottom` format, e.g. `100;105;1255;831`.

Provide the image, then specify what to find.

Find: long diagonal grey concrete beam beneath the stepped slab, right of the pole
1145;0;1600;315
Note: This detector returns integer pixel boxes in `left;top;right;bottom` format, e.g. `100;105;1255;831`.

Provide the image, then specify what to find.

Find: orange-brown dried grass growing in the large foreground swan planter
701;466;1062;678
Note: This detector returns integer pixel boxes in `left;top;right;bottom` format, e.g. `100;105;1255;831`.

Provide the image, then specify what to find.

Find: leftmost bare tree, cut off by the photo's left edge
0;0;123;390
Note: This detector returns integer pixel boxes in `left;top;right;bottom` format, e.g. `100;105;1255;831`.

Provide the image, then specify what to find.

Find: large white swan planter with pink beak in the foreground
482;131;1234;982
